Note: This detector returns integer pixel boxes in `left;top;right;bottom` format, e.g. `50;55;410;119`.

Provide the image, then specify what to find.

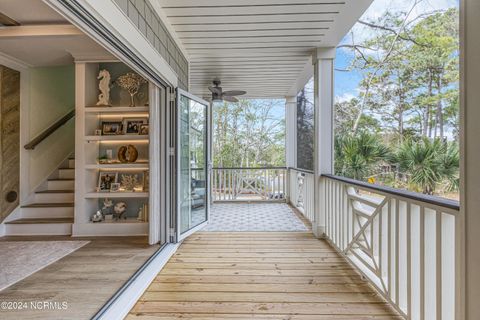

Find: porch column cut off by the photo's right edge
462;0;480;320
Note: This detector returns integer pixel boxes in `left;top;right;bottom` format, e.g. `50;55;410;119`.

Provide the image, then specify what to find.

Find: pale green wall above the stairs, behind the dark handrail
27;65;75;192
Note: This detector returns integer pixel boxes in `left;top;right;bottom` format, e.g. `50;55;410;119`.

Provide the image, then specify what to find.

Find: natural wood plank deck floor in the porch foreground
127;232;401;320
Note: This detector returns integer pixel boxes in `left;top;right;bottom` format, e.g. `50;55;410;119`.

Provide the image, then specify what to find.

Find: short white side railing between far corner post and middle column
288;168;315;223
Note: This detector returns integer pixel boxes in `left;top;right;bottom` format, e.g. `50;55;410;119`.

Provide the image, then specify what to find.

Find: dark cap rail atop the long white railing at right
322;174;460;210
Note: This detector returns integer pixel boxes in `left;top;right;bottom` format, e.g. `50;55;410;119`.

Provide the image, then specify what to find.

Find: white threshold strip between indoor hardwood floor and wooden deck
95;244;179;320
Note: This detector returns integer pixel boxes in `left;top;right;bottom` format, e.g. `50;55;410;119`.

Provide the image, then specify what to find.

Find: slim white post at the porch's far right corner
285;96;297;168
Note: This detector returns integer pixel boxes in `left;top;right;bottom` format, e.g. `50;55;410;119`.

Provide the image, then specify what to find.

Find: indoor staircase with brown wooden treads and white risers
5;159;75;236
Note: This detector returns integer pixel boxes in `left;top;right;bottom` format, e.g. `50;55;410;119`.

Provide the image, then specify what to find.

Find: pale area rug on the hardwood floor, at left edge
0;241;90;291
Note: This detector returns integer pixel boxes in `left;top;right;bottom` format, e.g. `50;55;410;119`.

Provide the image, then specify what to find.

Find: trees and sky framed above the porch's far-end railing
213;100;285;167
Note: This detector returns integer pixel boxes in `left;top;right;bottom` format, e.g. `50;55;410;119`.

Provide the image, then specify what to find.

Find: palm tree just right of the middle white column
335;132;390;180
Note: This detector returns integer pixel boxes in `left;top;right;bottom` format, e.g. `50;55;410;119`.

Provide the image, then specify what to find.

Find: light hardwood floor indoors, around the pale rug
0;236;159;320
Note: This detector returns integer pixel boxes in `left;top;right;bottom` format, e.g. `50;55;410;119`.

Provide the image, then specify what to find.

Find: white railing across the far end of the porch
212;167;287;201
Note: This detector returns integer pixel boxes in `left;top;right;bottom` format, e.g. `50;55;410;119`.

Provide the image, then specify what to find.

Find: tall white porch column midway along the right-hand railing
312;48;335;237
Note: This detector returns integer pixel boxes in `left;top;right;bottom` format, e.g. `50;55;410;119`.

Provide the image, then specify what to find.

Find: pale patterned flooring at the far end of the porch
202;203;308;232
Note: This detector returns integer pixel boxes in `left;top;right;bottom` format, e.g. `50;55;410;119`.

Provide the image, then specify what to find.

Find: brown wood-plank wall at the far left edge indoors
0;66;20;222
